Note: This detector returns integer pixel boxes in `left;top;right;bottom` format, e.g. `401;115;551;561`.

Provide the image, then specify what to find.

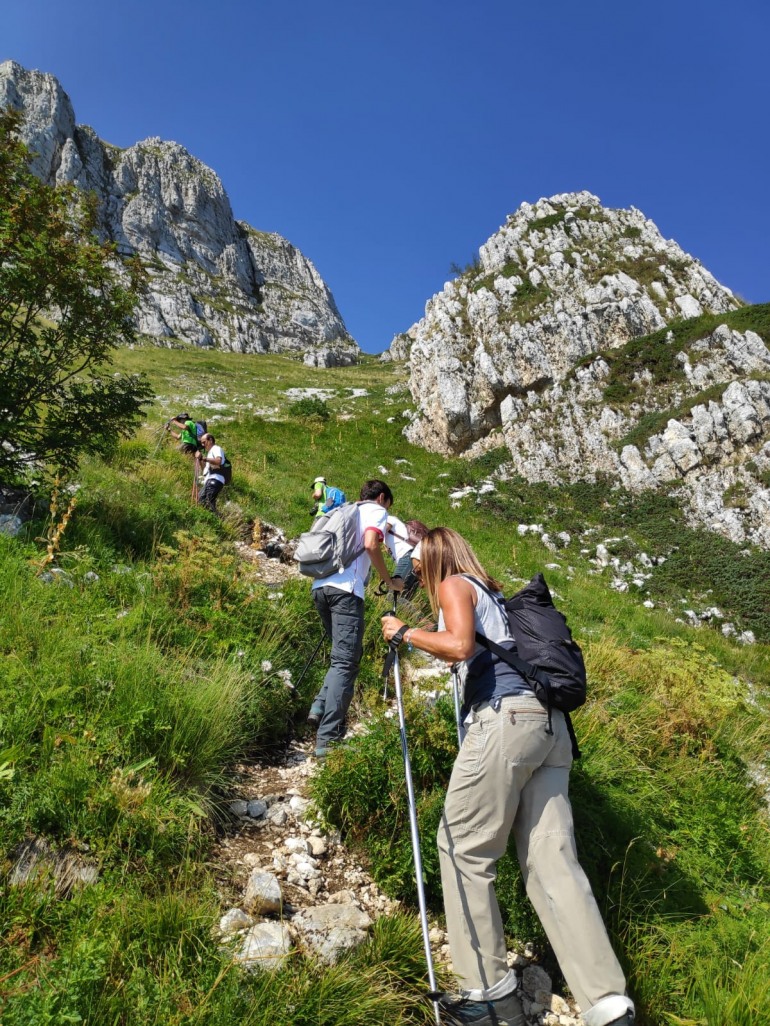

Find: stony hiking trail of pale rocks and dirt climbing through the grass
211;523;582;1026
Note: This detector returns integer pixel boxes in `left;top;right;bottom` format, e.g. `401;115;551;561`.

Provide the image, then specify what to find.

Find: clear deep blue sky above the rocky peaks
6;0;770;352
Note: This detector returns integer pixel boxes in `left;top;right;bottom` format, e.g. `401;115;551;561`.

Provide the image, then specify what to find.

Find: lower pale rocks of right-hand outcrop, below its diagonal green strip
494;325;770;548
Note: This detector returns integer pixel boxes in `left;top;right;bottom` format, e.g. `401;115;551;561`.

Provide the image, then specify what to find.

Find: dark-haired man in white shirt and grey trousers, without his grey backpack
308;480;400;758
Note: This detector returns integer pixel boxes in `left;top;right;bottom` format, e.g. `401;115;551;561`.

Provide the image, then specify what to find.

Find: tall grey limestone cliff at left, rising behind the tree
0;61;358;366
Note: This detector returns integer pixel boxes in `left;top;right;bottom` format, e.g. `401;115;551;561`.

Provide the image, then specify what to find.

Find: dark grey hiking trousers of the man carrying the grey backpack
313;585;363;748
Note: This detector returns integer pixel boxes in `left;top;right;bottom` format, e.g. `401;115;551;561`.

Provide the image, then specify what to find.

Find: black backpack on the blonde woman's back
471;574;586;758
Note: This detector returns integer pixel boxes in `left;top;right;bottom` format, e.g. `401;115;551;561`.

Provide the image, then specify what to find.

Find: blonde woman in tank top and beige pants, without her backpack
383;527;634;1026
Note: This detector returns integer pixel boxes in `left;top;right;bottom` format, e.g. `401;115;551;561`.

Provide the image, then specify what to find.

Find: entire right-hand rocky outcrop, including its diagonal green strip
392;193;770;547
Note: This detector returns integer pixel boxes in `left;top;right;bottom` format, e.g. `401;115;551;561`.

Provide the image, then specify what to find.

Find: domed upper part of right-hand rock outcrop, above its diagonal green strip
407;192;738;452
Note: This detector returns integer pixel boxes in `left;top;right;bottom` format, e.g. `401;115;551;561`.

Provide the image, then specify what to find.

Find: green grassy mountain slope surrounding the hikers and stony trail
0;348;770;1026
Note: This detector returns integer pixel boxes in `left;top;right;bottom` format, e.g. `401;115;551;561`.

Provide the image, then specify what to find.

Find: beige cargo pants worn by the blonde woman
438;696;625;1012
